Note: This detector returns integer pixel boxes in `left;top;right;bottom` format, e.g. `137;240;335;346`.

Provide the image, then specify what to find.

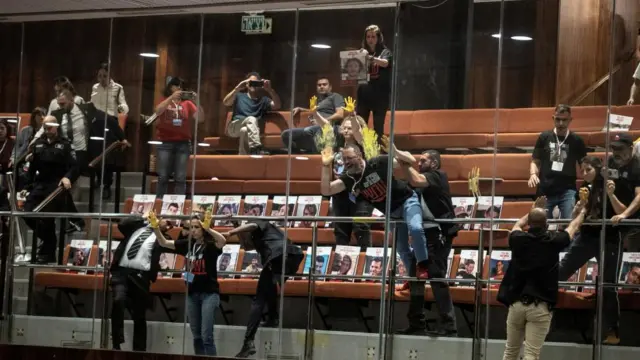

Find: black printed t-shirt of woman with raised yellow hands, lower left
175;234;222;293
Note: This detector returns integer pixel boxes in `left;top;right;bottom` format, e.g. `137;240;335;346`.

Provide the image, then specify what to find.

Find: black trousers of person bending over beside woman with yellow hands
244;257;286;341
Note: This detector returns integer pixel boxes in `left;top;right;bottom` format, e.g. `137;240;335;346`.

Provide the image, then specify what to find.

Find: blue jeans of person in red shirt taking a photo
156;141;191;199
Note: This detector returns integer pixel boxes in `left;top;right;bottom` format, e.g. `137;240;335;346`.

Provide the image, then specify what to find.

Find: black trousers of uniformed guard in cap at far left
24;182;75;256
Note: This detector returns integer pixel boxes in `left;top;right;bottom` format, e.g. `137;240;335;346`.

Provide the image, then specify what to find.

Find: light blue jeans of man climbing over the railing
391;191;429;269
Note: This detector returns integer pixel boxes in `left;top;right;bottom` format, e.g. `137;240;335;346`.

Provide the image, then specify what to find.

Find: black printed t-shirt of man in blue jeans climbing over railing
340;155;413;213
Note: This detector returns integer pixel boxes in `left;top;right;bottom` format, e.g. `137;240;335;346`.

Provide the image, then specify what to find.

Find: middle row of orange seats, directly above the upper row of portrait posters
151;152;604;197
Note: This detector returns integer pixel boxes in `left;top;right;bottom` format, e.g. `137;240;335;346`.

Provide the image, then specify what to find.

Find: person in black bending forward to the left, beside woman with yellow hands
223;220;304;358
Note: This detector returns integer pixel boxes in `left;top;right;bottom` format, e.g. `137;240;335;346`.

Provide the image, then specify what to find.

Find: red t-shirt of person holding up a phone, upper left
156;98;198;141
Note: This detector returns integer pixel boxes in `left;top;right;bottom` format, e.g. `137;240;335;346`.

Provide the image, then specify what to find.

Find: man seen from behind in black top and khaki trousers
497;197;586;360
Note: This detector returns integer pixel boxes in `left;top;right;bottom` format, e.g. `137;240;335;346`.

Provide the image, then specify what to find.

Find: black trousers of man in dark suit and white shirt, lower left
111;272;150;351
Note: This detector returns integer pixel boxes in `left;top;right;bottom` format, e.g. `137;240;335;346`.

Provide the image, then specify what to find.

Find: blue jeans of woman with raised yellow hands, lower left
187;293;220;356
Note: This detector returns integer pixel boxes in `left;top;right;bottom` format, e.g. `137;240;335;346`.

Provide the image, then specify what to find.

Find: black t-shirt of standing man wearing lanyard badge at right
533;130;587;196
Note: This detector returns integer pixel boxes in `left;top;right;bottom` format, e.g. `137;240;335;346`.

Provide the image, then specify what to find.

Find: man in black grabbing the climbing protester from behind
396;150;460;336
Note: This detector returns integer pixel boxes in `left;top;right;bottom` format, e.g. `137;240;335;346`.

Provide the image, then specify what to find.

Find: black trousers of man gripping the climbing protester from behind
407;229;457;331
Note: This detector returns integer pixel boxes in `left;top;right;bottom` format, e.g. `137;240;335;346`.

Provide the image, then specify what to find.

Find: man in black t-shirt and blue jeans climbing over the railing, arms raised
320;145;429;279
